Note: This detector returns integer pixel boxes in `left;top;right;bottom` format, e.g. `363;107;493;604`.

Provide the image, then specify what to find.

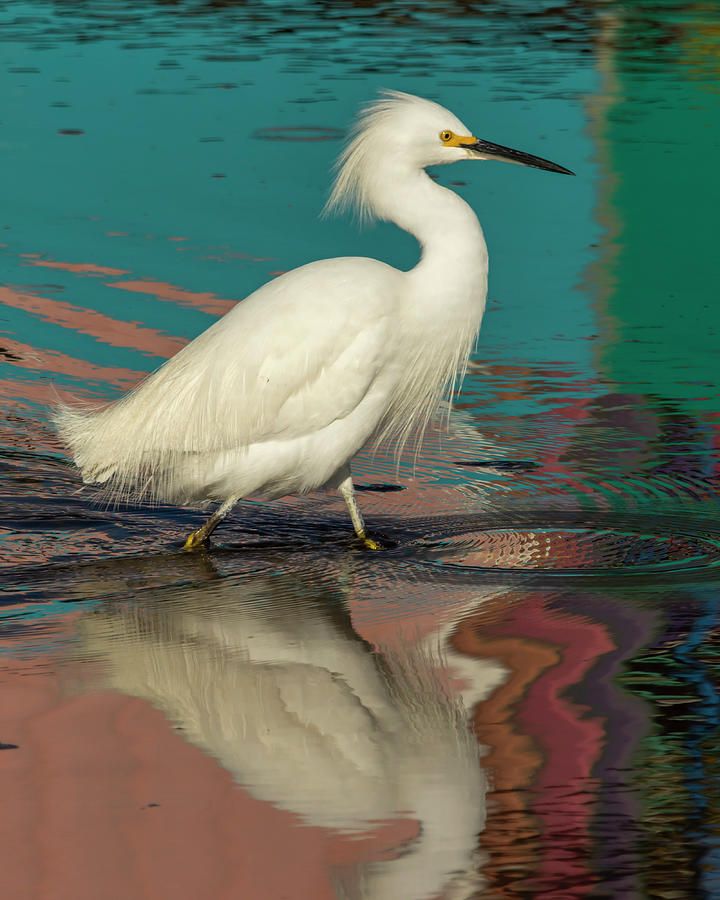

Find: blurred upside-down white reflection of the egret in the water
74;573;498;900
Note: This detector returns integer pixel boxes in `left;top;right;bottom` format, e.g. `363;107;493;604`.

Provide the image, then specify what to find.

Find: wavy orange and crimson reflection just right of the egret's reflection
453;599;615;900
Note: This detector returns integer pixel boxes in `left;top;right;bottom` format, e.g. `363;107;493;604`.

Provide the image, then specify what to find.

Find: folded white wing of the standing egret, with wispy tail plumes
56;258;401;502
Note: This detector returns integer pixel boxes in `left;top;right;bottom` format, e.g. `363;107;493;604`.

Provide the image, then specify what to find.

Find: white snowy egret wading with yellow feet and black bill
55;91;573;550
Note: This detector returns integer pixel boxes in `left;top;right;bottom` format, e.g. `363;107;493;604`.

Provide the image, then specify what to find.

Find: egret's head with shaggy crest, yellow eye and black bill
326;91;573;219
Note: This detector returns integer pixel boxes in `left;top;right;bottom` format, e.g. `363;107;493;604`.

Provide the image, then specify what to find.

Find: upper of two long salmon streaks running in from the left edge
0;287;187;358
